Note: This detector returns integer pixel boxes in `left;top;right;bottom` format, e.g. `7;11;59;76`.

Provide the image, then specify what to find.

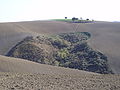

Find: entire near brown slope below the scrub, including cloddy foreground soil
0;56;120;90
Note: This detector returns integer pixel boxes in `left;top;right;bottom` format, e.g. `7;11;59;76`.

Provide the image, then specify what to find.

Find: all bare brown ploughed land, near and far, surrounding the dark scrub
0;21;120;90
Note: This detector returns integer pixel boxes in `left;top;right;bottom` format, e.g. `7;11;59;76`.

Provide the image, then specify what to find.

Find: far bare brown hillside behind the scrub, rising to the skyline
0;21;120;73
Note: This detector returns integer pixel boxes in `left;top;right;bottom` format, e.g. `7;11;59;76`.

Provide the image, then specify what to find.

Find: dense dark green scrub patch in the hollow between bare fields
7;32;113;74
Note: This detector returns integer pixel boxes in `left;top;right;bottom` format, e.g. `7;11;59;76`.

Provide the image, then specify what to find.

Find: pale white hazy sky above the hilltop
0;0;120;22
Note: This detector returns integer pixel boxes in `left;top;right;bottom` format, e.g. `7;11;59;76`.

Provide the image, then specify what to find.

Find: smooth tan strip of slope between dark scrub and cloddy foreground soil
0;55;94;75
